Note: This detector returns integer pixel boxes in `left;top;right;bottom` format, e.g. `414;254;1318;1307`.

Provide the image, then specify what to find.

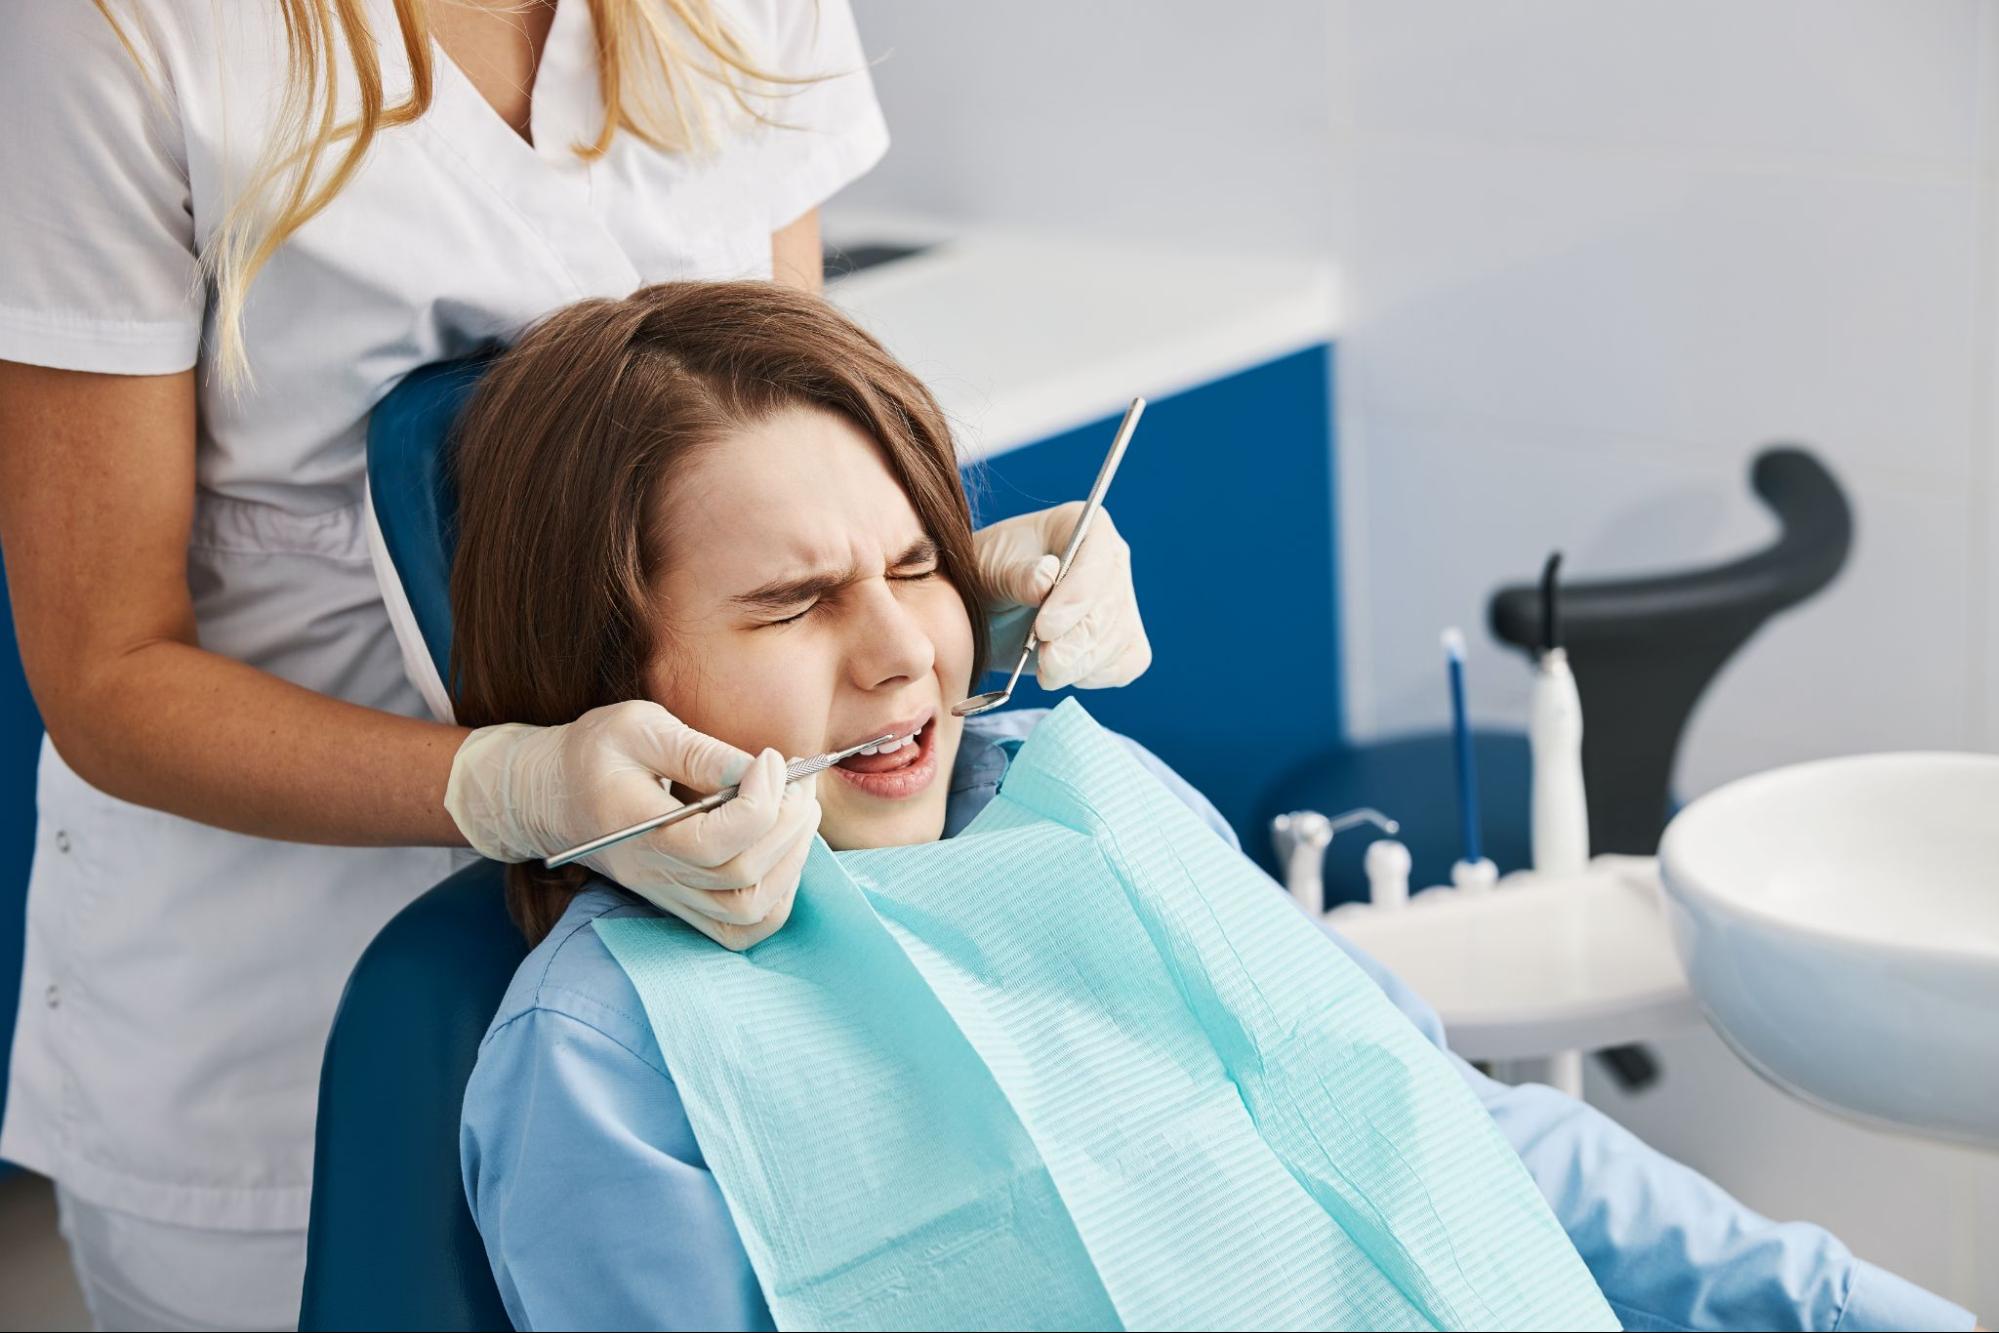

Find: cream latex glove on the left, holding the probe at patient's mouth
444;699;820;949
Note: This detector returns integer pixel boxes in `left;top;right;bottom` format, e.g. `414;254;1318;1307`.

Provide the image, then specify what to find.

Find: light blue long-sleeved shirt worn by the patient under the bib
460;709;1973;1331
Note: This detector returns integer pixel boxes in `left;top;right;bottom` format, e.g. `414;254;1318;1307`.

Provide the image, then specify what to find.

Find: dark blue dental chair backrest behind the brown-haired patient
298;362;528;1329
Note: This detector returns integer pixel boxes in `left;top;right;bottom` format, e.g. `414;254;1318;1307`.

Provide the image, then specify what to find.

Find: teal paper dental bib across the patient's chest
596;701;1617;1329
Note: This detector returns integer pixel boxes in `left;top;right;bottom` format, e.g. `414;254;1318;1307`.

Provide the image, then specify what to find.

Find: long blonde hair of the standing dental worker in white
94;0;826;384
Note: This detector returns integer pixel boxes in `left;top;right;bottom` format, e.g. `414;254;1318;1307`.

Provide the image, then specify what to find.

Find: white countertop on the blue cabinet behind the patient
828;218;1335;460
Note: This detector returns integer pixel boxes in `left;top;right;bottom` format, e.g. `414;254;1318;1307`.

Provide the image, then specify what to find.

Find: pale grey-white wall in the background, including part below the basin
834;0;1999;1317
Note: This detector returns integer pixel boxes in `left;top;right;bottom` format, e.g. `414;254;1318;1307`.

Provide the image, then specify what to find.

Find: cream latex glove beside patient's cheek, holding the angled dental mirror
972;500;1151;689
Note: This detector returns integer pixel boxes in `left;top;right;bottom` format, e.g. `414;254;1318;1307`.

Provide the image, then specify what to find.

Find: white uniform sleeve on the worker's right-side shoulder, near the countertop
744;0;888;230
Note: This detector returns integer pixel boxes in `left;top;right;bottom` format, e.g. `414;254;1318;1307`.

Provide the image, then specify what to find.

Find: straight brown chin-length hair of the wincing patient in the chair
452;282;988;941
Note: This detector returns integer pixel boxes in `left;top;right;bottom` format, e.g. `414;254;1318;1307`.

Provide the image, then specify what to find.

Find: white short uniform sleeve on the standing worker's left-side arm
0;0;202;376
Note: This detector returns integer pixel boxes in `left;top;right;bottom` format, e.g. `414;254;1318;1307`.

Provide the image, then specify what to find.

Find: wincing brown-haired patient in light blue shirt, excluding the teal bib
454;284;1973;1329
